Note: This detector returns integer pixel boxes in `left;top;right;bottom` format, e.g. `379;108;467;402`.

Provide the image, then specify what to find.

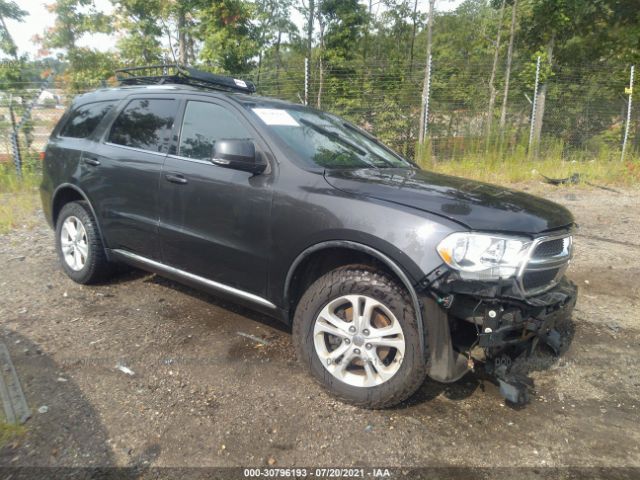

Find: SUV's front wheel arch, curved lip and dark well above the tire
283;240;425;352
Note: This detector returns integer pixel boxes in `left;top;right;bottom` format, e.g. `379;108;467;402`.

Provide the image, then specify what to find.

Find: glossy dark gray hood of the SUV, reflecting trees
325;168;574;234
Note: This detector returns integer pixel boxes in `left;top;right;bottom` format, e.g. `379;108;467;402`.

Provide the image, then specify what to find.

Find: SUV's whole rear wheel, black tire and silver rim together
56;202;112;284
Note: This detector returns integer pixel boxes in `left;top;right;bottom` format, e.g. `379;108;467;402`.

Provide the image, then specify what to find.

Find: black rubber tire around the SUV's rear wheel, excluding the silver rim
56;201;113;284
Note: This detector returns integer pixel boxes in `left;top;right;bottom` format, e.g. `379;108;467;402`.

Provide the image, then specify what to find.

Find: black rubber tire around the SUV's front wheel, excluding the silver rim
293;265;428;409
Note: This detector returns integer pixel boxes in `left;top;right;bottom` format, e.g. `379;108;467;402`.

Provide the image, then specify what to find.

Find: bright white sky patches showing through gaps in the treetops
7;0;462;59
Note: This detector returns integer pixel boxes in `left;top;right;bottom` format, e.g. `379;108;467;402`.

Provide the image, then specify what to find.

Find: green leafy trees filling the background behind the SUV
0;0;640;161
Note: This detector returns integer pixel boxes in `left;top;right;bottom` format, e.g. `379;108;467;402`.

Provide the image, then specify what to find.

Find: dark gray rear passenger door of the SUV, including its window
82;96;178;259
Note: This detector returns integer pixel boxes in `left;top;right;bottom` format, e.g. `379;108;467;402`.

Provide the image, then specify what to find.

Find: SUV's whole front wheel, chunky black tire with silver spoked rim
293;266;427;408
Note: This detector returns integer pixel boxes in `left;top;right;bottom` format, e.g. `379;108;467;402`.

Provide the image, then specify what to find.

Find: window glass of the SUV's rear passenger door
107;98;178;152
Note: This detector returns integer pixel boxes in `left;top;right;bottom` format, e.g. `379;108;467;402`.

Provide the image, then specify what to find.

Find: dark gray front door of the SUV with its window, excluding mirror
160;97;272;295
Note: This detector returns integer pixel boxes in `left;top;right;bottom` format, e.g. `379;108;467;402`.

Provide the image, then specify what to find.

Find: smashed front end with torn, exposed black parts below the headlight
418;265;577;404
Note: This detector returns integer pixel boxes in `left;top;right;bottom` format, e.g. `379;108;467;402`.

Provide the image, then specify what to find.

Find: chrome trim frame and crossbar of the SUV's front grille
516;234;573;297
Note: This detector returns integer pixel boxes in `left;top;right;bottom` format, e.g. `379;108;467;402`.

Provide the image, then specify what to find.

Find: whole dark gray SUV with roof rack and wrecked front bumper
41;68;576;408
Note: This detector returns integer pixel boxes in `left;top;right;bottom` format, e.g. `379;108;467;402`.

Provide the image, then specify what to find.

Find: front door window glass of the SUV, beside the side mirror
178;102;251;160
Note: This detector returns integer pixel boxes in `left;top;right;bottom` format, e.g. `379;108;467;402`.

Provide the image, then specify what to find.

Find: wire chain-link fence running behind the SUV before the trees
0;59;640;174
